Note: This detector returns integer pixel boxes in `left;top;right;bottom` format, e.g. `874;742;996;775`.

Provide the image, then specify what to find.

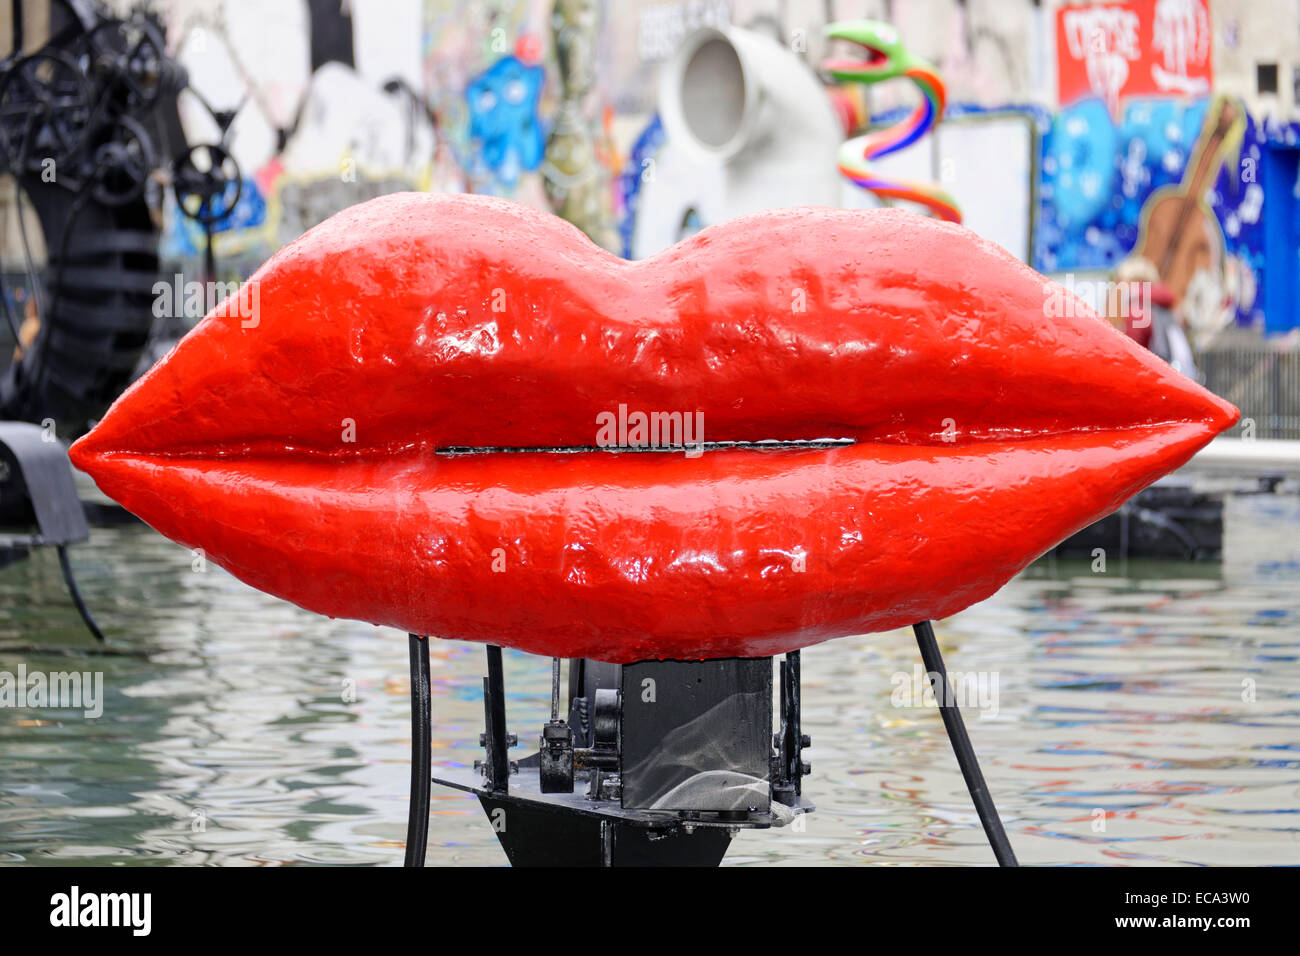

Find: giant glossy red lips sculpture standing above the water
72;194;1238;662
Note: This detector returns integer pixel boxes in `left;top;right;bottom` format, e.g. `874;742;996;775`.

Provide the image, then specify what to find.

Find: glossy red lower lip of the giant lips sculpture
83;424;1212;662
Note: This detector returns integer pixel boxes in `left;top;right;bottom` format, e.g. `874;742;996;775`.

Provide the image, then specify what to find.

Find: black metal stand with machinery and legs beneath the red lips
406;632;1018;866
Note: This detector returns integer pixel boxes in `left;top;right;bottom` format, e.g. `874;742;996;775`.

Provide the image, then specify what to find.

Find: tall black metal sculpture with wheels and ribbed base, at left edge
0;0;172;438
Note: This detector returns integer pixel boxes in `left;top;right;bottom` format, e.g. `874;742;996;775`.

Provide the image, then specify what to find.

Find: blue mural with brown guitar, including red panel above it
1032;0;1297;342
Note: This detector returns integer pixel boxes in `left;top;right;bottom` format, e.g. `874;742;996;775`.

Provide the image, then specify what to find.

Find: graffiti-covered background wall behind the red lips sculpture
154;0;1300;334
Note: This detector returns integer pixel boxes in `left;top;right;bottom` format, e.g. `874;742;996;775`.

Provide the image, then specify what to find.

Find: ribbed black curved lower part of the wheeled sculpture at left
0;176;159;441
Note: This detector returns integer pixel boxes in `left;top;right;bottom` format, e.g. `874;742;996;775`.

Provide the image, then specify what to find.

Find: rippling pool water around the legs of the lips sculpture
0;496;1300;865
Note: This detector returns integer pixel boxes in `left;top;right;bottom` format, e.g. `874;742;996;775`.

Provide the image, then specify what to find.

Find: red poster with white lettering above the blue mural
1057;0;1213;112
